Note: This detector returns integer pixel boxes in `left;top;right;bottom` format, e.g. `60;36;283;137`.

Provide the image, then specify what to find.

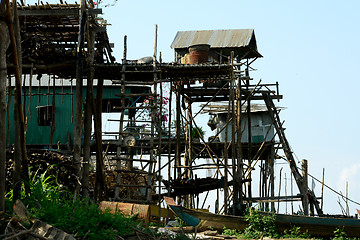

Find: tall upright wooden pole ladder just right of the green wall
114;64;162;204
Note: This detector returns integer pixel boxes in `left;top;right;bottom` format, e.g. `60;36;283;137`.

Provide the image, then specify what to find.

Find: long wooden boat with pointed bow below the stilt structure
164;197;360;238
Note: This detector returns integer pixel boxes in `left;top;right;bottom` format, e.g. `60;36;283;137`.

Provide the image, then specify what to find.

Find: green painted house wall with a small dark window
5;86;135;146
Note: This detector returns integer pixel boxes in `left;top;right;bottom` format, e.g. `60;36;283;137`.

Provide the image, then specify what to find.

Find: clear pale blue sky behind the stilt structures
103;0;360;214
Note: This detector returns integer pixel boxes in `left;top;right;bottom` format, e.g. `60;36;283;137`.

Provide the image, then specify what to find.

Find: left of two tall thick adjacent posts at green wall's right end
73;0;87;199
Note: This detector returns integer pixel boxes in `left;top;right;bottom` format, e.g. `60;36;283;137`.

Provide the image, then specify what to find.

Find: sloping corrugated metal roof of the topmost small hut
171;29;257;50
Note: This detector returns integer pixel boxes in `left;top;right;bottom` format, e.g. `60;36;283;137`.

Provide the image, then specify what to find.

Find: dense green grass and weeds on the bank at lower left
7;167;188;240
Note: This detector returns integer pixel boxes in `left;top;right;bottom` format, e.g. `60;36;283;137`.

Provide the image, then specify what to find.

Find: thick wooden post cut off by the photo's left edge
0;1;10;212
